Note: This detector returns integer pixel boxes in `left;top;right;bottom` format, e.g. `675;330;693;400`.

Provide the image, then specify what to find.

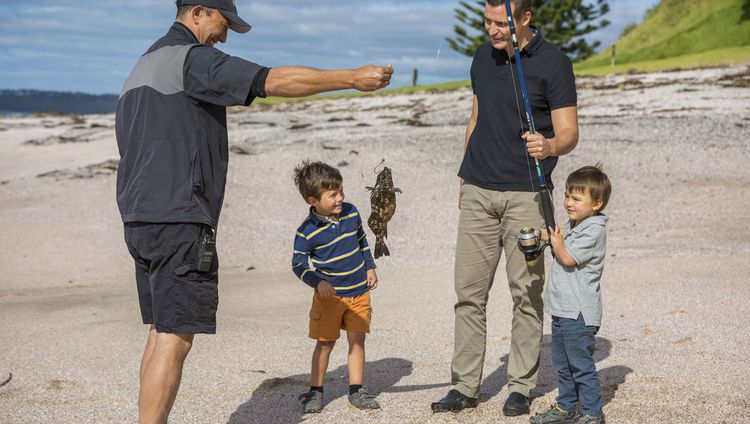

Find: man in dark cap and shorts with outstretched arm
115;0;393;423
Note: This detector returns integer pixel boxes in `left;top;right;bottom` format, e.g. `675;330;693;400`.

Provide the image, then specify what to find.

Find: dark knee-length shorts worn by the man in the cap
125;222;219;334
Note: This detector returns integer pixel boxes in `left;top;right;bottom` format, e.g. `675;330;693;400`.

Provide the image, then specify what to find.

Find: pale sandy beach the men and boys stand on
0;67;750;424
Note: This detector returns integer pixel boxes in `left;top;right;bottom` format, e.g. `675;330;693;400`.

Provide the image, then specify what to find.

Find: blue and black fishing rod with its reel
505;0;555;261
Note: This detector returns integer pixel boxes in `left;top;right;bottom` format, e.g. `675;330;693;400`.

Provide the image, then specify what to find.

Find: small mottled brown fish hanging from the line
365;166;401;259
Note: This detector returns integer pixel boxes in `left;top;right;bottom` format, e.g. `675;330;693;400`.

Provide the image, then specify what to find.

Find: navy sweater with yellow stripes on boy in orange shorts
292;203;375;297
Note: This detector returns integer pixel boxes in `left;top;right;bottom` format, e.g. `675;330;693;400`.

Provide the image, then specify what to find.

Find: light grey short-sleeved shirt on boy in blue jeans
544;214;608;327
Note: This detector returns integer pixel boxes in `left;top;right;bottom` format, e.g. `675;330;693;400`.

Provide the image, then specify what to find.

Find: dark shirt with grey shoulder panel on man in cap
115;23;268;227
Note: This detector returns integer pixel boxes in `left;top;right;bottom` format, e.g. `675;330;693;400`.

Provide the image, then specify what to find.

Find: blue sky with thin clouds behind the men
0;0;657;94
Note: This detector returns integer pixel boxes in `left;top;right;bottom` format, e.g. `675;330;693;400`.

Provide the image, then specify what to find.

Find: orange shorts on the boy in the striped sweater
309;290;372;342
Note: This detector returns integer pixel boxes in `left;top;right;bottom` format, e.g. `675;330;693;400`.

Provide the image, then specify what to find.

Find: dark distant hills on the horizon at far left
0;89;118;114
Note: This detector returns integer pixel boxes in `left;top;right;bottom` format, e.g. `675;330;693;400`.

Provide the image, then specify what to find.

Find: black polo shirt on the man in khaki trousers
458;31;577;191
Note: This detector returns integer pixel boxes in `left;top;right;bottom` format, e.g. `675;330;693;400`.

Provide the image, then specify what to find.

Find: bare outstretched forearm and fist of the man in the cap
265;65;393;97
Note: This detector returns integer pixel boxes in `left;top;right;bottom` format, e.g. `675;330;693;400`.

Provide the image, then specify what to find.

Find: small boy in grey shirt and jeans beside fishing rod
531;166;612;424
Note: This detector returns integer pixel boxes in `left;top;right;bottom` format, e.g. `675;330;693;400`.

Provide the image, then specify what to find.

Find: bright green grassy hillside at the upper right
576;0;750;71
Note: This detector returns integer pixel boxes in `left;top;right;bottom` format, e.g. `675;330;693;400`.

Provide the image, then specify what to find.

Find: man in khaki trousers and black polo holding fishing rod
432;0;578;415
